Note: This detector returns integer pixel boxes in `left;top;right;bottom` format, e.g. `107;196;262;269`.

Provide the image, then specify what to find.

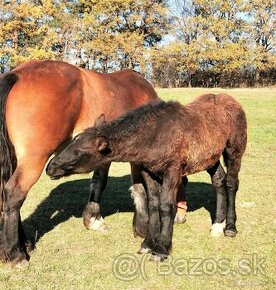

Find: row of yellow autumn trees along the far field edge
0;0;276;87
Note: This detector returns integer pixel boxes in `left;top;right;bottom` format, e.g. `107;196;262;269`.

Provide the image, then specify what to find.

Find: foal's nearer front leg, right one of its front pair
151;167;181;261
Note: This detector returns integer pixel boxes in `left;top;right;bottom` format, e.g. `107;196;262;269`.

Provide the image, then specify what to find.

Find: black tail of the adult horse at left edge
0;73;18;206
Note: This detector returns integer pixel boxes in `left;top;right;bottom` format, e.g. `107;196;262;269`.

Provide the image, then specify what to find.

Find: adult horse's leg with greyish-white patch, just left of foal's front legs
129;163;149;238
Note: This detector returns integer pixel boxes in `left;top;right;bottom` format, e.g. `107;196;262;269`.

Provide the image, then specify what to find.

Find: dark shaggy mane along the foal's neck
86;100;180;139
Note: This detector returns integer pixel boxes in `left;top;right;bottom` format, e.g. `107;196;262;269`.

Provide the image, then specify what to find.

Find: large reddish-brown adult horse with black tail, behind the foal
0;61;168;265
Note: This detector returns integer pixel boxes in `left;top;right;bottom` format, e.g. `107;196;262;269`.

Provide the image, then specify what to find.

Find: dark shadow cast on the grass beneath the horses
23;175;216;243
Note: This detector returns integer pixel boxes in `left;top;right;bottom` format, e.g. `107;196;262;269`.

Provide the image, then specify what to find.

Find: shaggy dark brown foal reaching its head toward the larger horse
47;94;247;260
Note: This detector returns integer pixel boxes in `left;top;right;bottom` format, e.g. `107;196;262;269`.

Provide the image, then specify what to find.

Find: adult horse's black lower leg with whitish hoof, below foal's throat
82;163;110;232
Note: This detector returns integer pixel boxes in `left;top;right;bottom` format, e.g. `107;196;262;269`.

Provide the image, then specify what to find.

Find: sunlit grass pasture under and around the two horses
0;89;276;290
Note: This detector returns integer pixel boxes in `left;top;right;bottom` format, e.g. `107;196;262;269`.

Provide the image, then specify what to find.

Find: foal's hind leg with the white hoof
207;161;227;237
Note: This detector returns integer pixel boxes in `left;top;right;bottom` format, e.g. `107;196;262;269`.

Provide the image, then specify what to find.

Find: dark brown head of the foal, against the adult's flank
46;113;110;179
